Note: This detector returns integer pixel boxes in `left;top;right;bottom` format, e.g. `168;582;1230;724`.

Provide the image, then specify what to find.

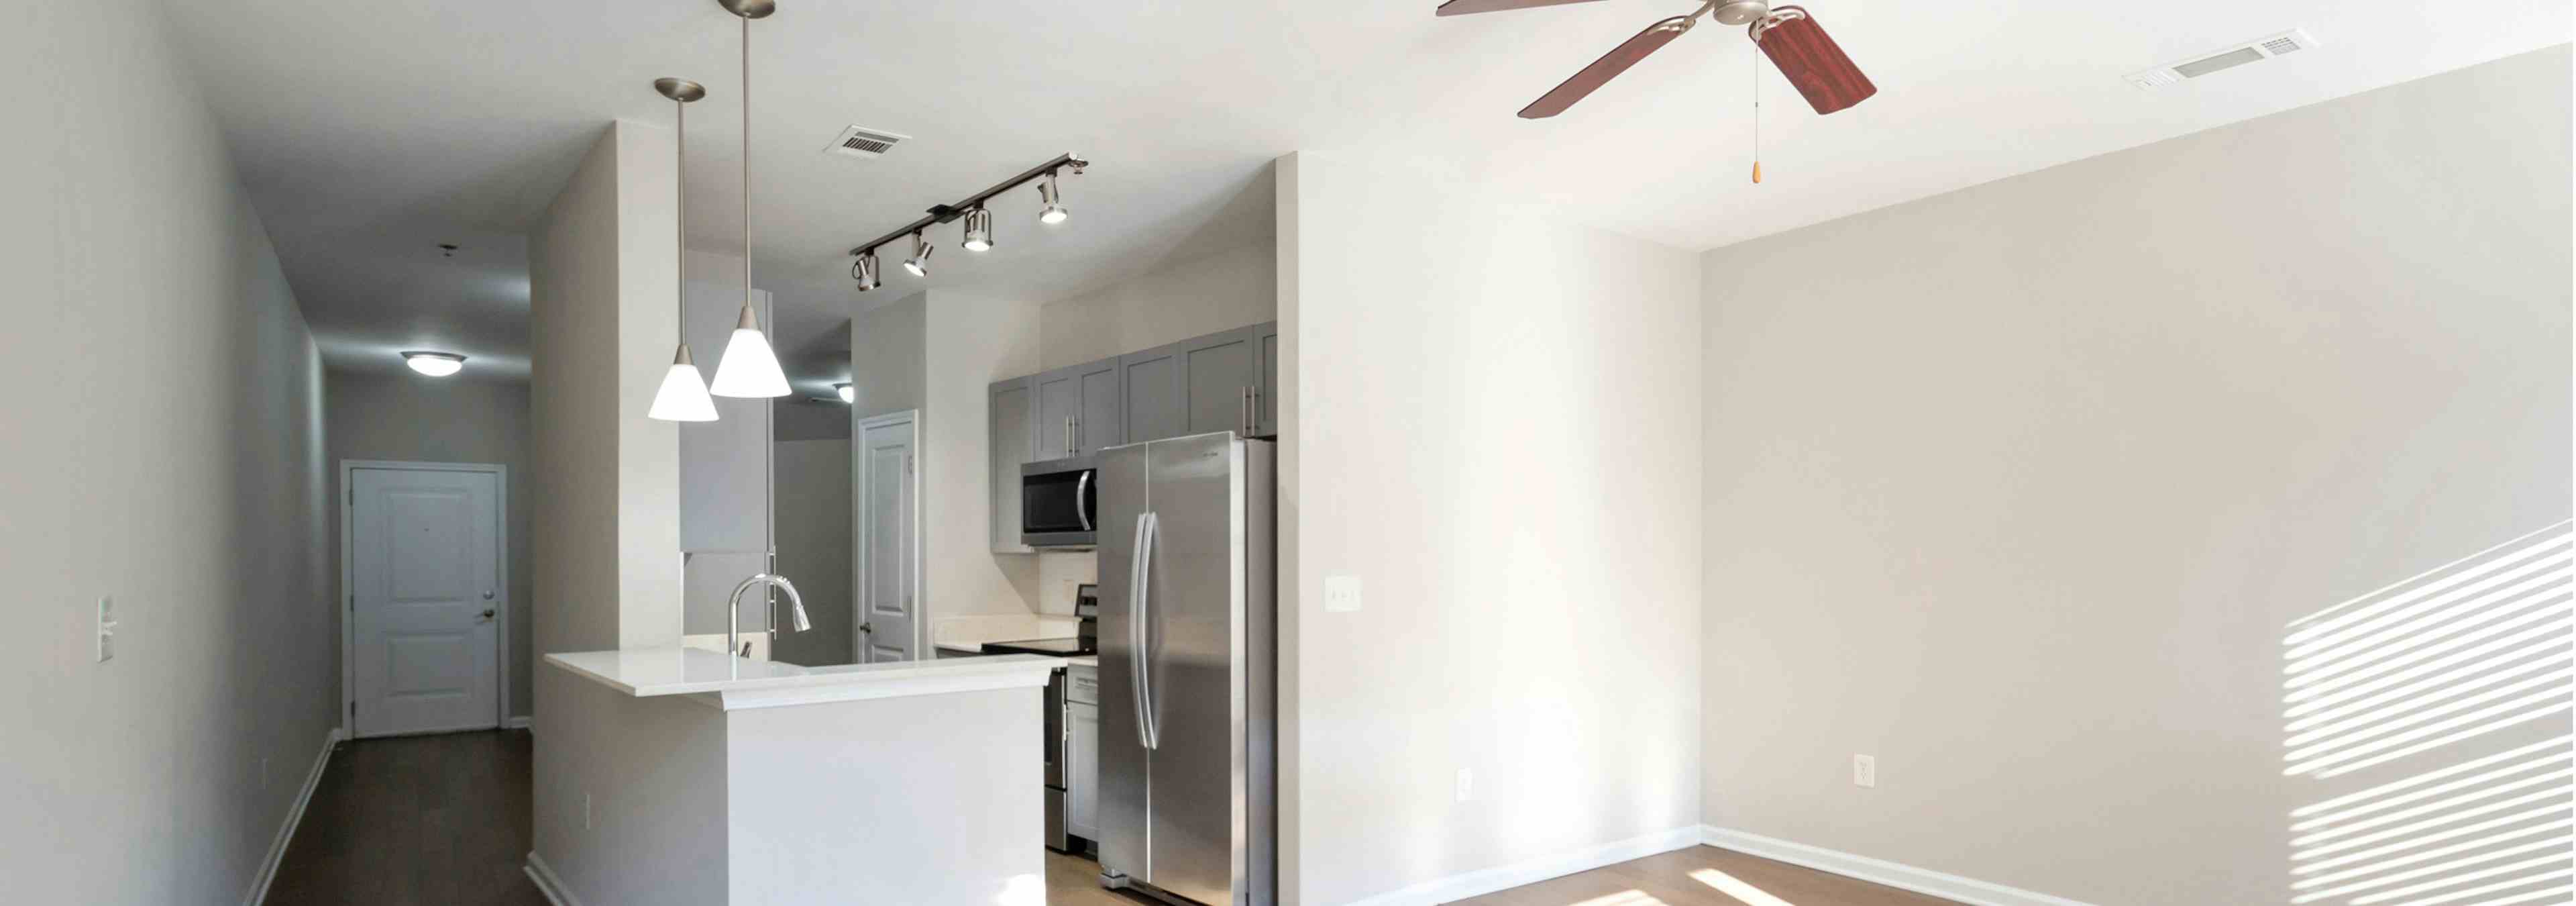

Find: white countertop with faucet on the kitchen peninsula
546;646;1064;711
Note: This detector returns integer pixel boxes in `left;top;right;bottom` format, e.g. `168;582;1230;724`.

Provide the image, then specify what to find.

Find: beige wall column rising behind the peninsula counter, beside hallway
528;121;685;654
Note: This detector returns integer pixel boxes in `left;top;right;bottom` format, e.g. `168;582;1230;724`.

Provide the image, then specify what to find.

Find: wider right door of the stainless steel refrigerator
1146;435;1249;903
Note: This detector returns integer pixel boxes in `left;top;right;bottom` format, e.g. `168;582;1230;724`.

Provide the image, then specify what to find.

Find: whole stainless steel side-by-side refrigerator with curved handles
1095;432;1278;906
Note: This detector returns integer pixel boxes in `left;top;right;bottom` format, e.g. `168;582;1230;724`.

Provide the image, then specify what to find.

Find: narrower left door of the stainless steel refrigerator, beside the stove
1095;445;1151;880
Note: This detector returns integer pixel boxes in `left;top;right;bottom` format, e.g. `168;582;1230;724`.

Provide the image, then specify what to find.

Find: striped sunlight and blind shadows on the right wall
2282;520;2576;906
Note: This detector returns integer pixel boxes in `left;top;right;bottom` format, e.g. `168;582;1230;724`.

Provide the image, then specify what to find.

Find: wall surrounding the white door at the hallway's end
325;370;546;715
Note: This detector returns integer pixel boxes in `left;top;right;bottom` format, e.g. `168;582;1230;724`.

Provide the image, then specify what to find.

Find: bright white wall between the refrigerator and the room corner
1278;152;1703;903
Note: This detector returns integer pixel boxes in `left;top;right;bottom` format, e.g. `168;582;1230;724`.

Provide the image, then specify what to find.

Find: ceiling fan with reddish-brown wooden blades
1440;0;1878;118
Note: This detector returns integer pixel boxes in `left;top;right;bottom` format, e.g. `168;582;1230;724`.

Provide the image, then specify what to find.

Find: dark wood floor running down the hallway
268;731;546;906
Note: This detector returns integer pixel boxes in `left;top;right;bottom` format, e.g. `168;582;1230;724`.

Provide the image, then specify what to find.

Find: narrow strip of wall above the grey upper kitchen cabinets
1038;237;1278;370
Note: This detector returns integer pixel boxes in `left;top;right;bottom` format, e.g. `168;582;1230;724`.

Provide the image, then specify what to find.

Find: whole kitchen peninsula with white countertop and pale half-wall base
528;648;1064;906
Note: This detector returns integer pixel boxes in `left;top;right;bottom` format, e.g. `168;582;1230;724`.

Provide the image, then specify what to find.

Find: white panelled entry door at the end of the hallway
347;468;502;736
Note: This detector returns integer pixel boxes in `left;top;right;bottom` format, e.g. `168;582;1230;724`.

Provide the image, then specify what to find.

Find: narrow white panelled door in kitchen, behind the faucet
850;412;922;664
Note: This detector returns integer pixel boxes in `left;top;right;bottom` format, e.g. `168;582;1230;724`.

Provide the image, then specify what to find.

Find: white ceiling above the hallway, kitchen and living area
170;0;2571;376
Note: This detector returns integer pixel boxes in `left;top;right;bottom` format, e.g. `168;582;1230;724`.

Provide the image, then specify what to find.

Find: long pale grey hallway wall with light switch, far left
0;0;337;906
